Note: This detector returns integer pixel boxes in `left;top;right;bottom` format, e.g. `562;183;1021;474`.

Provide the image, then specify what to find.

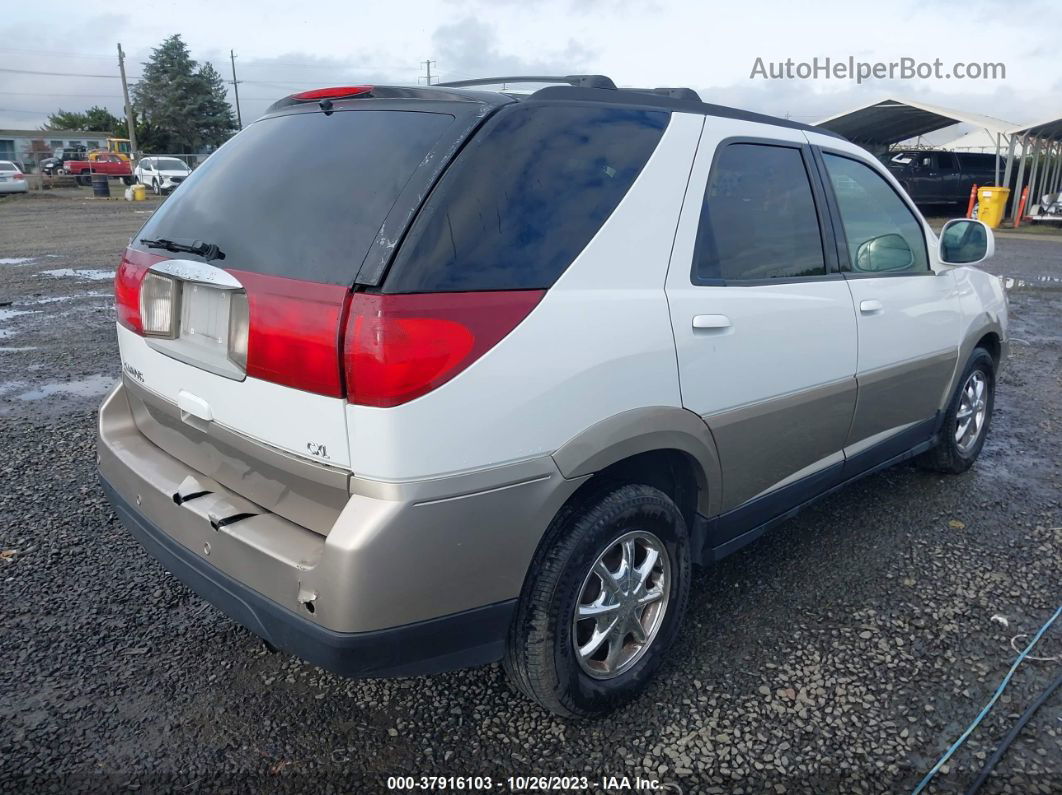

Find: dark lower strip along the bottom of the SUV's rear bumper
100;473;516;676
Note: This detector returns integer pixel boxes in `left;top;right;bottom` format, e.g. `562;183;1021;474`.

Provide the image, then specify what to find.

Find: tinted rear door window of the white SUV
690;143;826;284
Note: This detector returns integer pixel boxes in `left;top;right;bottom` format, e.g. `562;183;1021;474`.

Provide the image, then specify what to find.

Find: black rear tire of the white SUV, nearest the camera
502;484;690;718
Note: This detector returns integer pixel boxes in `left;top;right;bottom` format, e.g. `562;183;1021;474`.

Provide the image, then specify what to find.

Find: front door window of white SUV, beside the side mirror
823;153;929;273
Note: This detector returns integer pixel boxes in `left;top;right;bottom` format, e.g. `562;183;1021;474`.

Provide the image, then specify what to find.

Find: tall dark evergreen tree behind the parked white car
133;35;236;154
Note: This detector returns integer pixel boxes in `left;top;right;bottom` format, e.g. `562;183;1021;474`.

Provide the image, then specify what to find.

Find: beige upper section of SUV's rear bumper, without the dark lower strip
98;385;586;633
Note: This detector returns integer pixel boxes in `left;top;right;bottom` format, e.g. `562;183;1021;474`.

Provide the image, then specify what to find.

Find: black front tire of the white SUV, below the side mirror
918;348;995;474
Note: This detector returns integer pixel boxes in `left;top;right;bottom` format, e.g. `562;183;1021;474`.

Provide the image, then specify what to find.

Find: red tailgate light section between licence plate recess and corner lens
230;271;349;397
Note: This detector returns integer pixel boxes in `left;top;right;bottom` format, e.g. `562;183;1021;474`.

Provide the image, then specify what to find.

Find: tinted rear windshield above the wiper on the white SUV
136;110;453;284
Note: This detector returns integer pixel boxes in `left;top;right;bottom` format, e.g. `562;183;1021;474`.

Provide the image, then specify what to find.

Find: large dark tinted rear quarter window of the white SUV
384;103;669;293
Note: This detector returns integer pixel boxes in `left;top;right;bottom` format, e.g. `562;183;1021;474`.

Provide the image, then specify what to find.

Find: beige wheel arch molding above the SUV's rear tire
553;405;722;517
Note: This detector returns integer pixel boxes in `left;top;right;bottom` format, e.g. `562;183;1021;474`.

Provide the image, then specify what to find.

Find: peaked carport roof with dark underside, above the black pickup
815;99;1014;146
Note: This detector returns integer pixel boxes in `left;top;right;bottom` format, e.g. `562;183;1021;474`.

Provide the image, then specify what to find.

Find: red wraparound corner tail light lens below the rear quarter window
343;290;545;408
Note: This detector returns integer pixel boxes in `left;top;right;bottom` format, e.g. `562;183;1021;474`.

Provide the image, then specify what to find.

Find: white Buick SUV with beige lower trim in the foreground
99;76;1007;715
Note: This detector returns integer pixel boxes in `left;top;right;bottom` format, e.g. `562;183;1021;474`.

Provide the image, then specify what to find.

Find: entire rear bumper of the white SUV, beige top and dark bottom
97;384;582;676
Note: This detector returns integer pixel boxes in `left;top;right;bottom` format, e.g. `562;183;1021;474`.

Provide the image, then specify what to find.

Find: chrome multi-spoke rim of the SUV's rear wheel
571;531;671;679
